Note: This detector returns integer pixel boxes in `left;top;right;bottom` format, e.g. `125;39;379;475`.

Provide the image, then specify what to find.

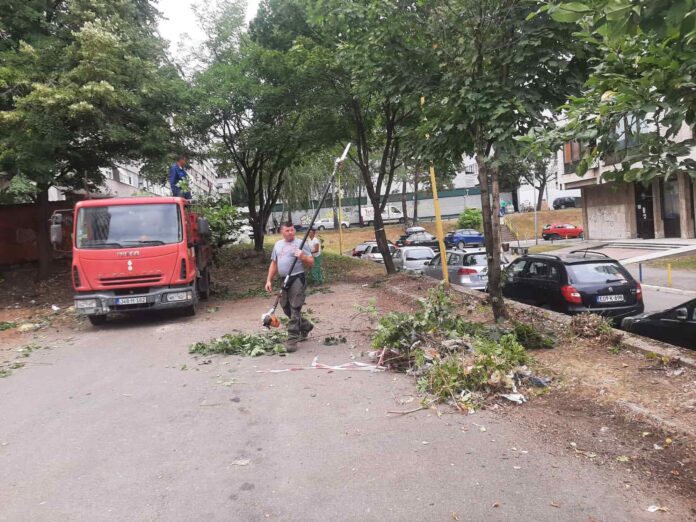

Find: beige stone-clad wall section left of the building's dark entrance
582;183;636;239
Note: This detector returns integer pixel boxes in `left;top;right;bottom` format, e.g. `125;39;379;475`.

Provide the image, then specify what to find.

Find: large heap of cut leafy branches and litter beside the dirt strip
372;286;553;410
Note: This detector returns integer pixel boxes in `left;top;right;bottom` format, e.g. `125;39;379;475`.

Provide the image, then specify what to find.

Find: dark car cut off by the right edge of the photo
621;299;696;349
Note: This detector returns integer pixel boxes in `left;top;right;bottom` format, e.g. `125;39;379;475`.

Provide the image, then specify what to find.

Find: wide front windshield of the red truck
75;203;183;248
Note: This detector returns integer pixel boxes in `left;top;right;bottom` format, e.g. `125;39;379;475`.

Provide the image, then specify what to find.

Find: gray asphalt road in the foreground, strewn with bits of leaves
0;289;677;522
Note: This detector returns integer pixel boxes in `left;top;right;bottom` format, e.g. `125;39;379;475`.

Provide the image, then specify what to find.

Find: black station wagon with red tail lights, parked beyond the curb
503;250;644;322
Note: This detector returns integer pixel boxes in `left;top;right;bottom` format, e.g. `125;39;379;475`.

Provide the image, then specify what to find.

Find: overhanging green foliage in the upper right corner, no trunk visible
530;0;696;183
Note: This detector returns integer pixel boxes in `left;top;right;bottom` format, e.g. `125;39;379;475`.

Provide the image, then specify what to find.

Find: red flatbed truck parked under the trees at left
51;197;212;325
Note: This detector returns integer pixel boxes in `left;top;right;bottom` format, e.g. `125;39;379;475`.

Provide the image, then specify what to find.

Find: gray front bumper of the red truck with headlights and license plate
74;285;196;315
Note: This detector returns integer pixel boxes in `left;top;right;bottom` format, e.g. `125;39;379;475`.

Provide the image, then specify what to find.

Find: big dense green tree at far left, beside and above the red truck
0;0;182;277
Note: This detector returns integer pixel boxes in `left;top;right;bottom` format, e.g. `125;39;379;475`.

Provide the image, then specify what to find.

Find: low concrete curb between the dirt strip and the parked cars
385;278;696;370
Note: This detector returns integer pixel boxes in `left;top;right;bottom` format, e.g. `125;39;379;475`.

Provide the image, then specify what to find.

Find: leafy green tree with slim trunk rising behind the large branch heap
423;0;584;319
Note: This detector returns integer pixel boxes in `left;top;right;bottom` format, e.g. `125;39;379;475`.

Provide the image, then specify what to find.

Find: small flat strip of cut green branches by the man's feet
189;332;287;357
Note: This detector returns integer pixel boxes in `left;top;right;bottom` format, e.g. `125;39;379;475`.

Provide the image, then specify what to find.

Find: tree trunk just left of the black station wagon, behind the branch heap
476;153;507;321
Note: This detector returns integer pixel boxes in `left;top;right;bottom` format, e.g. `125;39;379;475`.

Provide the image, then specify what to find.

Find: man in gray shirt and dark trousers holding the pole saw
266;222;314;352
